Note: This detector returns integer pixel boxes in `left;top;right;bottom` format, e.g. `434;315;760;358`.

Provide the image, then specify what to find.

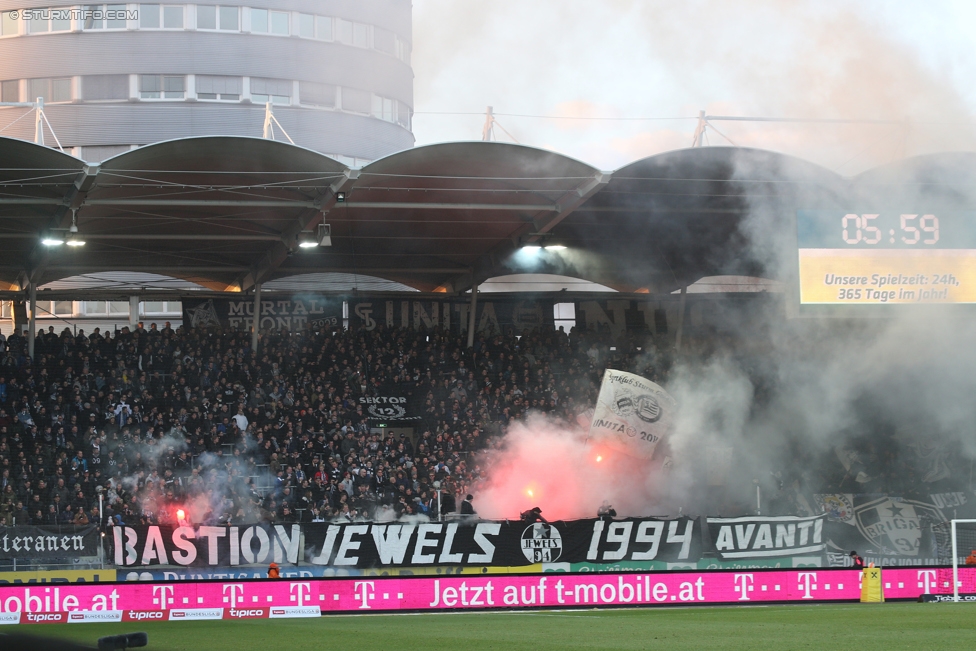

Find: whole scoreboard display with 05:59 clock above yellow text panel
796;211;976;305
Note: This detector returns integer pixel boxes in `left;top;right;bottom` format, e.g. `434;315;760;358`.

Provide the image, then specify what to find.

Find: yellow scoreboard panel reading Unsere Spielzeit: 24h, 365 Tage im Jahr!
800;249;976;305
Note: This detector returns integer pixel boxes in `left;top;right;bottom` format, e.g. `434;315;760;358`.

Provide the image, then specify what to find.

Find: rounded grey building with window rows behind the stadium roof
0;0;414;166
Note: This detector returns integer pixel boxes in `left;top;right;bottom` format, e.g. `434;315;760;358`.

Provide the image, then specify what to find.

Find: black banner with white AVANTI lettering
707;515;827;560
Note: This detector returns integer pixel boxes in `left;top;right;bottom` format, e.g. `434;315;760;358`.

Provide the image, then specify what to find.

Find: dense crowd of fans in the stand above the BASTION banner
0;324;671;525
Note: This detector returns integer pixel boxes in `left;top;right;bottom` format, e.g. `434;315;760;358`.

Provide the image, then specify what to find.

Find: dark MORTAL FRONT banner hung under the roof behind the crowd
183;294;342;332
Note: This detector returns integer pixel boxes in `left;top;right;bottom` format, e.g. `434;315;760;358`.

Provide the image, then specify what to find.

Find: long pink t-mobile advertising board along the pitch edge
0;568;976;624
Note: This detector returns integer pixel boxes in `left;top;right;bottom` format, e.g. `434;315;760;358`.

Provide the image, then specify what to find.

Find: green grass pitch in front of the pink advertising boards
13;603;976;651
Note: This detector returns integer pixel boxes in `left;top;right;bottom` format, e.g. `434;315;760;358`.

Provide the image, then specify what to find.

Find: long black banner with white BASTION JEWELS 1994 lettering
110;518;702;569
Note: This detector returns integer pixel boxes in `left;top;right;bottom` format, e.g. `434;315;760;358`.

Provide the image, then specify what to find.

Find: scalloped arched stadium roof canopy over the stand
0;136;976;300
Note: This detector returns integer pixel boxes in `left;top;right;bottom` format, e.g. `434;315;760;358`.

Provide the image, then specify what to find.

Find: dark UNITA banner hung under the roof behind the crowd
349;297;553;334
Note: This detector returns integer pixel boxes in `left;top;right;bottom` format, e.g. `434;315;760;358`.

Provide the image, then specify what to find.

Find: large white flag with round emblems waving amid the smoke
589;368;677;459
